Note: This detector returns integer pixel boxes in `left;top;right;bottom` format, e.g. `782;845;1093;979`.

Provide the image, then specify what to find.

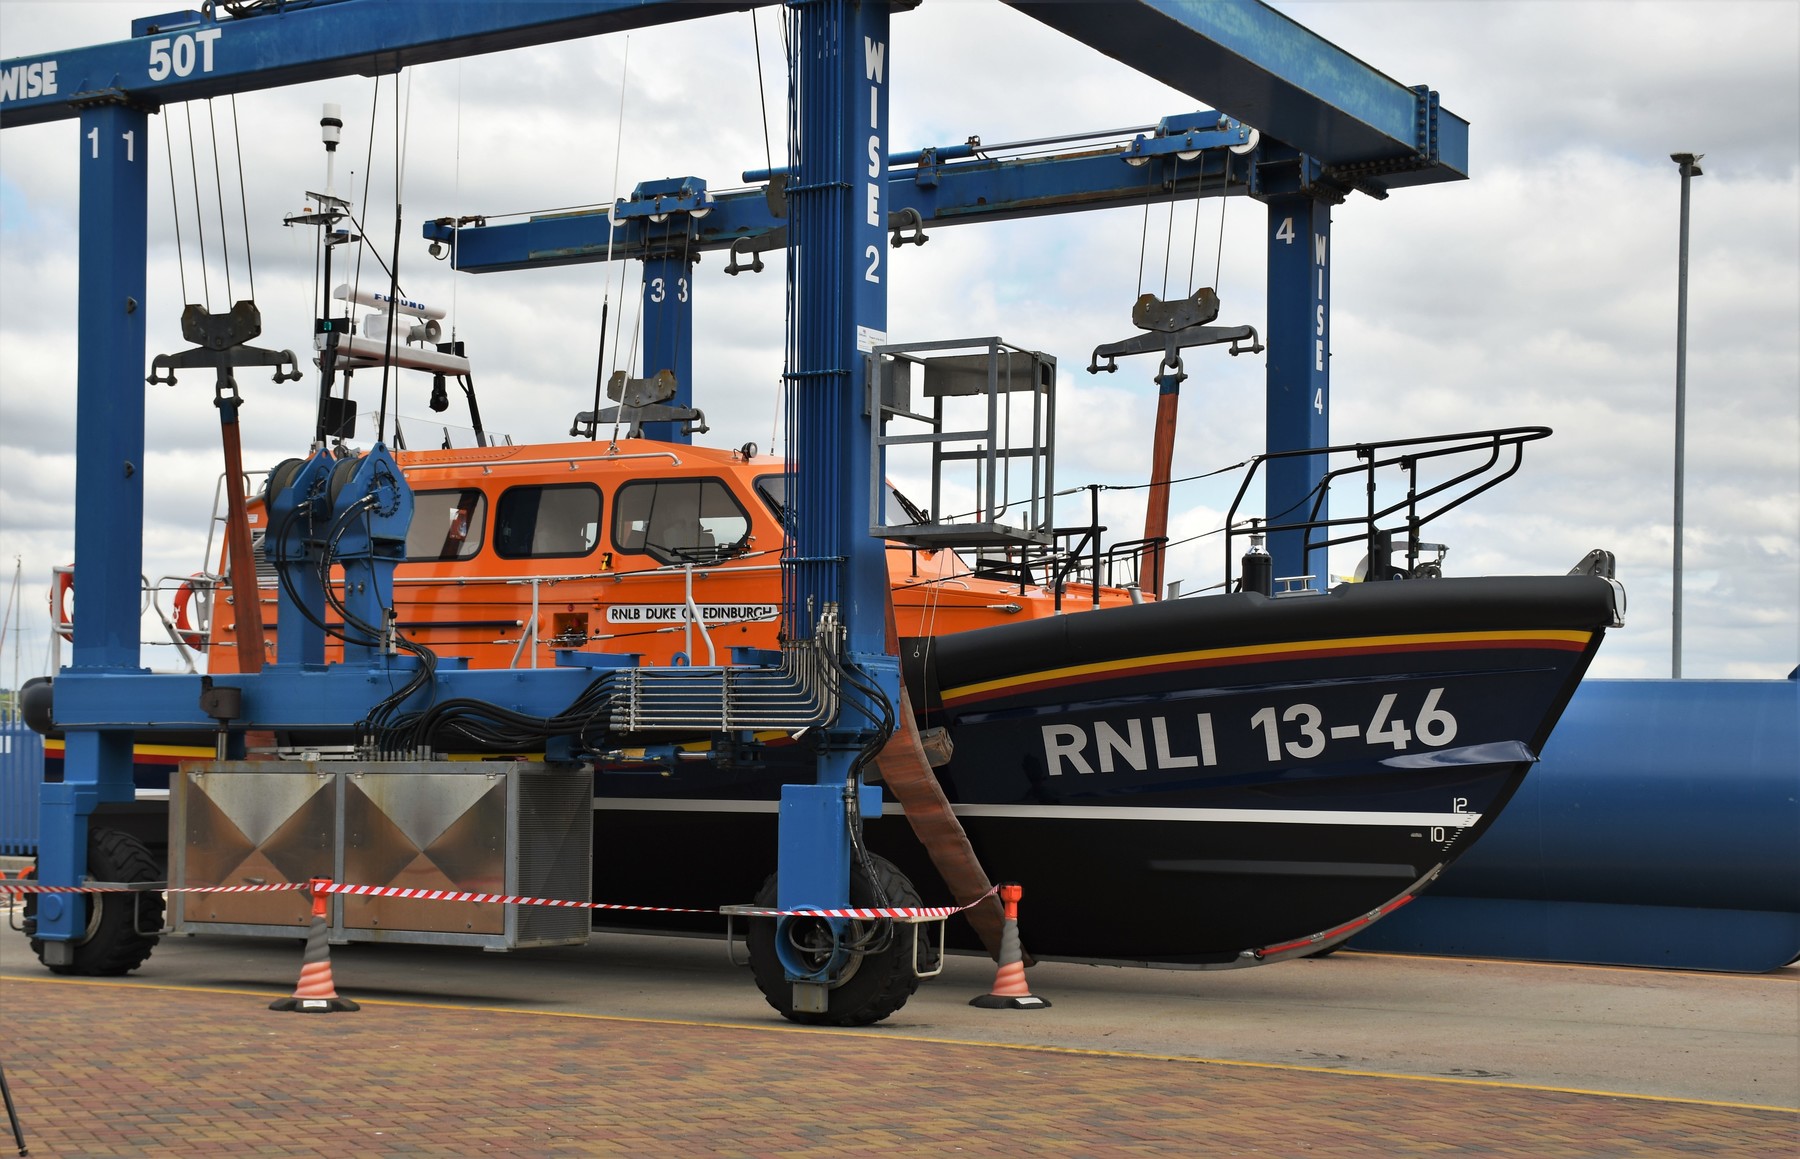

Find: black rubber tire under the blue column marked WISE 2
747;855;936;1026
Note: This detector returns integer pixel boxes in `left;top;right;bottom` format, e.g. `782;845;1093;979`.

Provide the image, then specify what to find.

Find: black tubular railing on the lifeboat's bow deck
1224;427;1552;594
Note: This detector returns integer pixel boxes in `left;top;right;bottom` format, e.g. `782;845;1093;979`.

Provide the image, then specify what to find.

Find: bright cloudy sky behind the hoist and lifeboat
0;0;1800;684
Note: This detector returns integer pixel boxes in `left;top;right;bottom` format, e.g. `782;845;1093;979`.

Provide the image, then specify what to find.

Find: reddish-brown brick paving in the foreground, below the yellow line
0;977;1800;1157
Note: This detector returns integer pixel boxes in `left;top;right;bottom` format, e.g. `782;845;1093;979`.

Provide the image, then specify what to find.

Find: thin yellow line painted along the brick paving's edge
10;975;1800;1114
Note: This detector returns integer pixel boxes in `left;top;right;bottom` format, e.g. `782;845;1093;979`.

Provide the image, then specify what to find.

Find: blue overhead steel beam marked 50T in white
0;0;772;128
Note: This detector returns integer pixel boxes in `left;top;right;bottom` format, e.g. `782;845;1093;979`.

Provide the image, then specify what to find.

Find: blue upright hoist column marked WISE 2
778;0;898;909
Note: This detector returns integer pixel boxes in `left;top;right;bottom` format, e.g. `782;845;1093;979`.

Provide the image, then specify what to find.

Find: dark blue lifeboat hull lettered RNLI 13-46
596;578;1613;966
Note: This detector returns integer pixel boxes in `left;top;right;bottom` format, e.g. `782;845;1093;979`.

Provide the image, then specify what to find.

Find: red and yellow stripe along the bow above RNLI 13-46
943;628;1593;704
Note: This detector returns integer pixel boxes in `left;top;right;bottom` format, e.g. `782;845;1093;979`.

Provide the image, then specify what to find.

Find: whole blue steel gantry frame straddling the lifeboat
0;0;1467;1015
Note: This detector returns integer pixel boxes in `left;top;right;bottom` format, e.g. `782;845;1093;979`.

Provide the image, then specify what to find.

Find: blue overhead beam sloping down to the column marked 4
1006;0;1469;185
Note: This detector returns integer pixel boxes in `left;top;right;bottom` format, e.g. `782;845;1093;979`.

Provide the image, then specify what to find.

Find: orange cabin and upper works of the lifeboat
211;431;1132;673
